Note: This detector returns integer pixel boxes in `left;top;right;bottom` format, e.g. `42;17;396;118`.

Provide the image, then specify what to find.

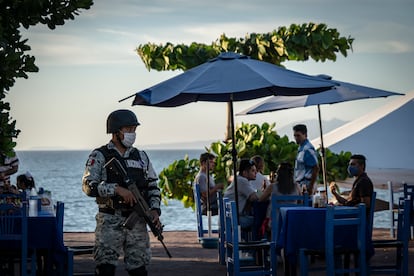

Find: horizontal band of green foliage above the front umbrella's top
136;23;354;71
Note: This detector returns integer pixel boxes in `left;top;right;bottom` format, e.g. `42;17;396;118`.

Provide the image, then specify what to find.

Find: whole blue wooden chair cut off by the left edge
0;202;36;276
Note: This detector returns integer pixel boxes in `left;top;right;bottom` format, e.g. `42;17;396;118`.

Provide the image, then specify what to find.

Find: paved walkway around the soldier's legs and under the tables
64;229;414;276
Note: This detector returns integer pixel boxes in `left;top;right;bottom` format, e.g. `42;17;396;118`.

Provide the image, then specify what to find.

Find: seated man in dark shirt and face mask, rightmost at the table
330;154;374;213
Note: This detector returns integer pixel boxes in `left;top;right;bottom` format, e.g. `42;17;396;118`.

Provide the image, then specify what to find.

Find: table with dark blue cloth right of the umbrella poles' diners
276;206;374;264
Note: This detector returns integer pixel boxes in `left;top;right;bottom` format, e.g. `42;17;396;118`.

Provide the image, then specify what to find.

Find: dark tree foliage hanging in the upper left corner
0;0;93;154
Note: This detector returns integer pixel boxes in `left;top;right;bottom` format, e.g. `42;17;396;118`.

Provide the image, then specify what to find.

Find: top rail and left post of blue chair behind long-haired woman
271;193;309;241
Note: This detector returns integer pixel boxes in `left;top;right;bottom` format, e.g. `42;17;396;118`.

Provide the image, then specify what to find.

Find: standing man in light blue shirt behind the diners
293;124;319;195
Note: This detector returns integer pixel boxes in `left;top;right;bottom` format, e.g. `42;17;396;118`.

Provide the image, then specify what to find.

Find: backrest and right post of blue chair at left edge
0;202;28;275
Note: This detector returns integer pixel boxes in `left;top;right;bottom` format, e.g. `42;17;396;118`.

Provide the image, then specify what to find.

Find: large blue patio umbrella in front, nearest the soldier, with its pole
120;52;337;223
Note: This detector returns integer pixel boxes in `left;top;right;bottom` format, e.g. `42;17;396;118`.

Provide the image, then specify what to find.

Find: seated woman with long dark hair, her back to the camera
261;162;301;235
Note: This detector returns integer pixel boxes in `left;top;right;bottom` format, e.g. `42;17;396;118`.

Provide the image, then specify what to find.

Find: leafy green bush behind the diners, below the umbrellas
159;123;351;208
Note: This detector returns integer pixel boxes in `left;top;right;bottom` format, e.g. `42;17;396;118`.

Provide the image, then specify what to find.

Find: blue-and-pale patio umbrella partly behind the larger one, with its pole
237;75;404;197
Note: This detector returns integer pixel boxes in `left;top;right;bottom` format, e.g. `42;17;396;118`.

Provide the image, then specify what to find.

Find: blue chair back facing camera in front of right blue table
325;204;367;275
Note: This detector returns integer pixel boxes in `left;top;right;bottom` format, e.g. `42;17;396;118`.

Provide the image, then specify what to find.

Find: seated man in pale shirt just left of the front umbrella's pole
194;152;223;216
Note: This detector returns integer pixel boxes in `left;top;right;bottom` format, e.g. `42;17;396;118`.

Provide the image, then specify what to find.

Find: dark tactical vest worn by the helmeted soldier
96;145;149;209
